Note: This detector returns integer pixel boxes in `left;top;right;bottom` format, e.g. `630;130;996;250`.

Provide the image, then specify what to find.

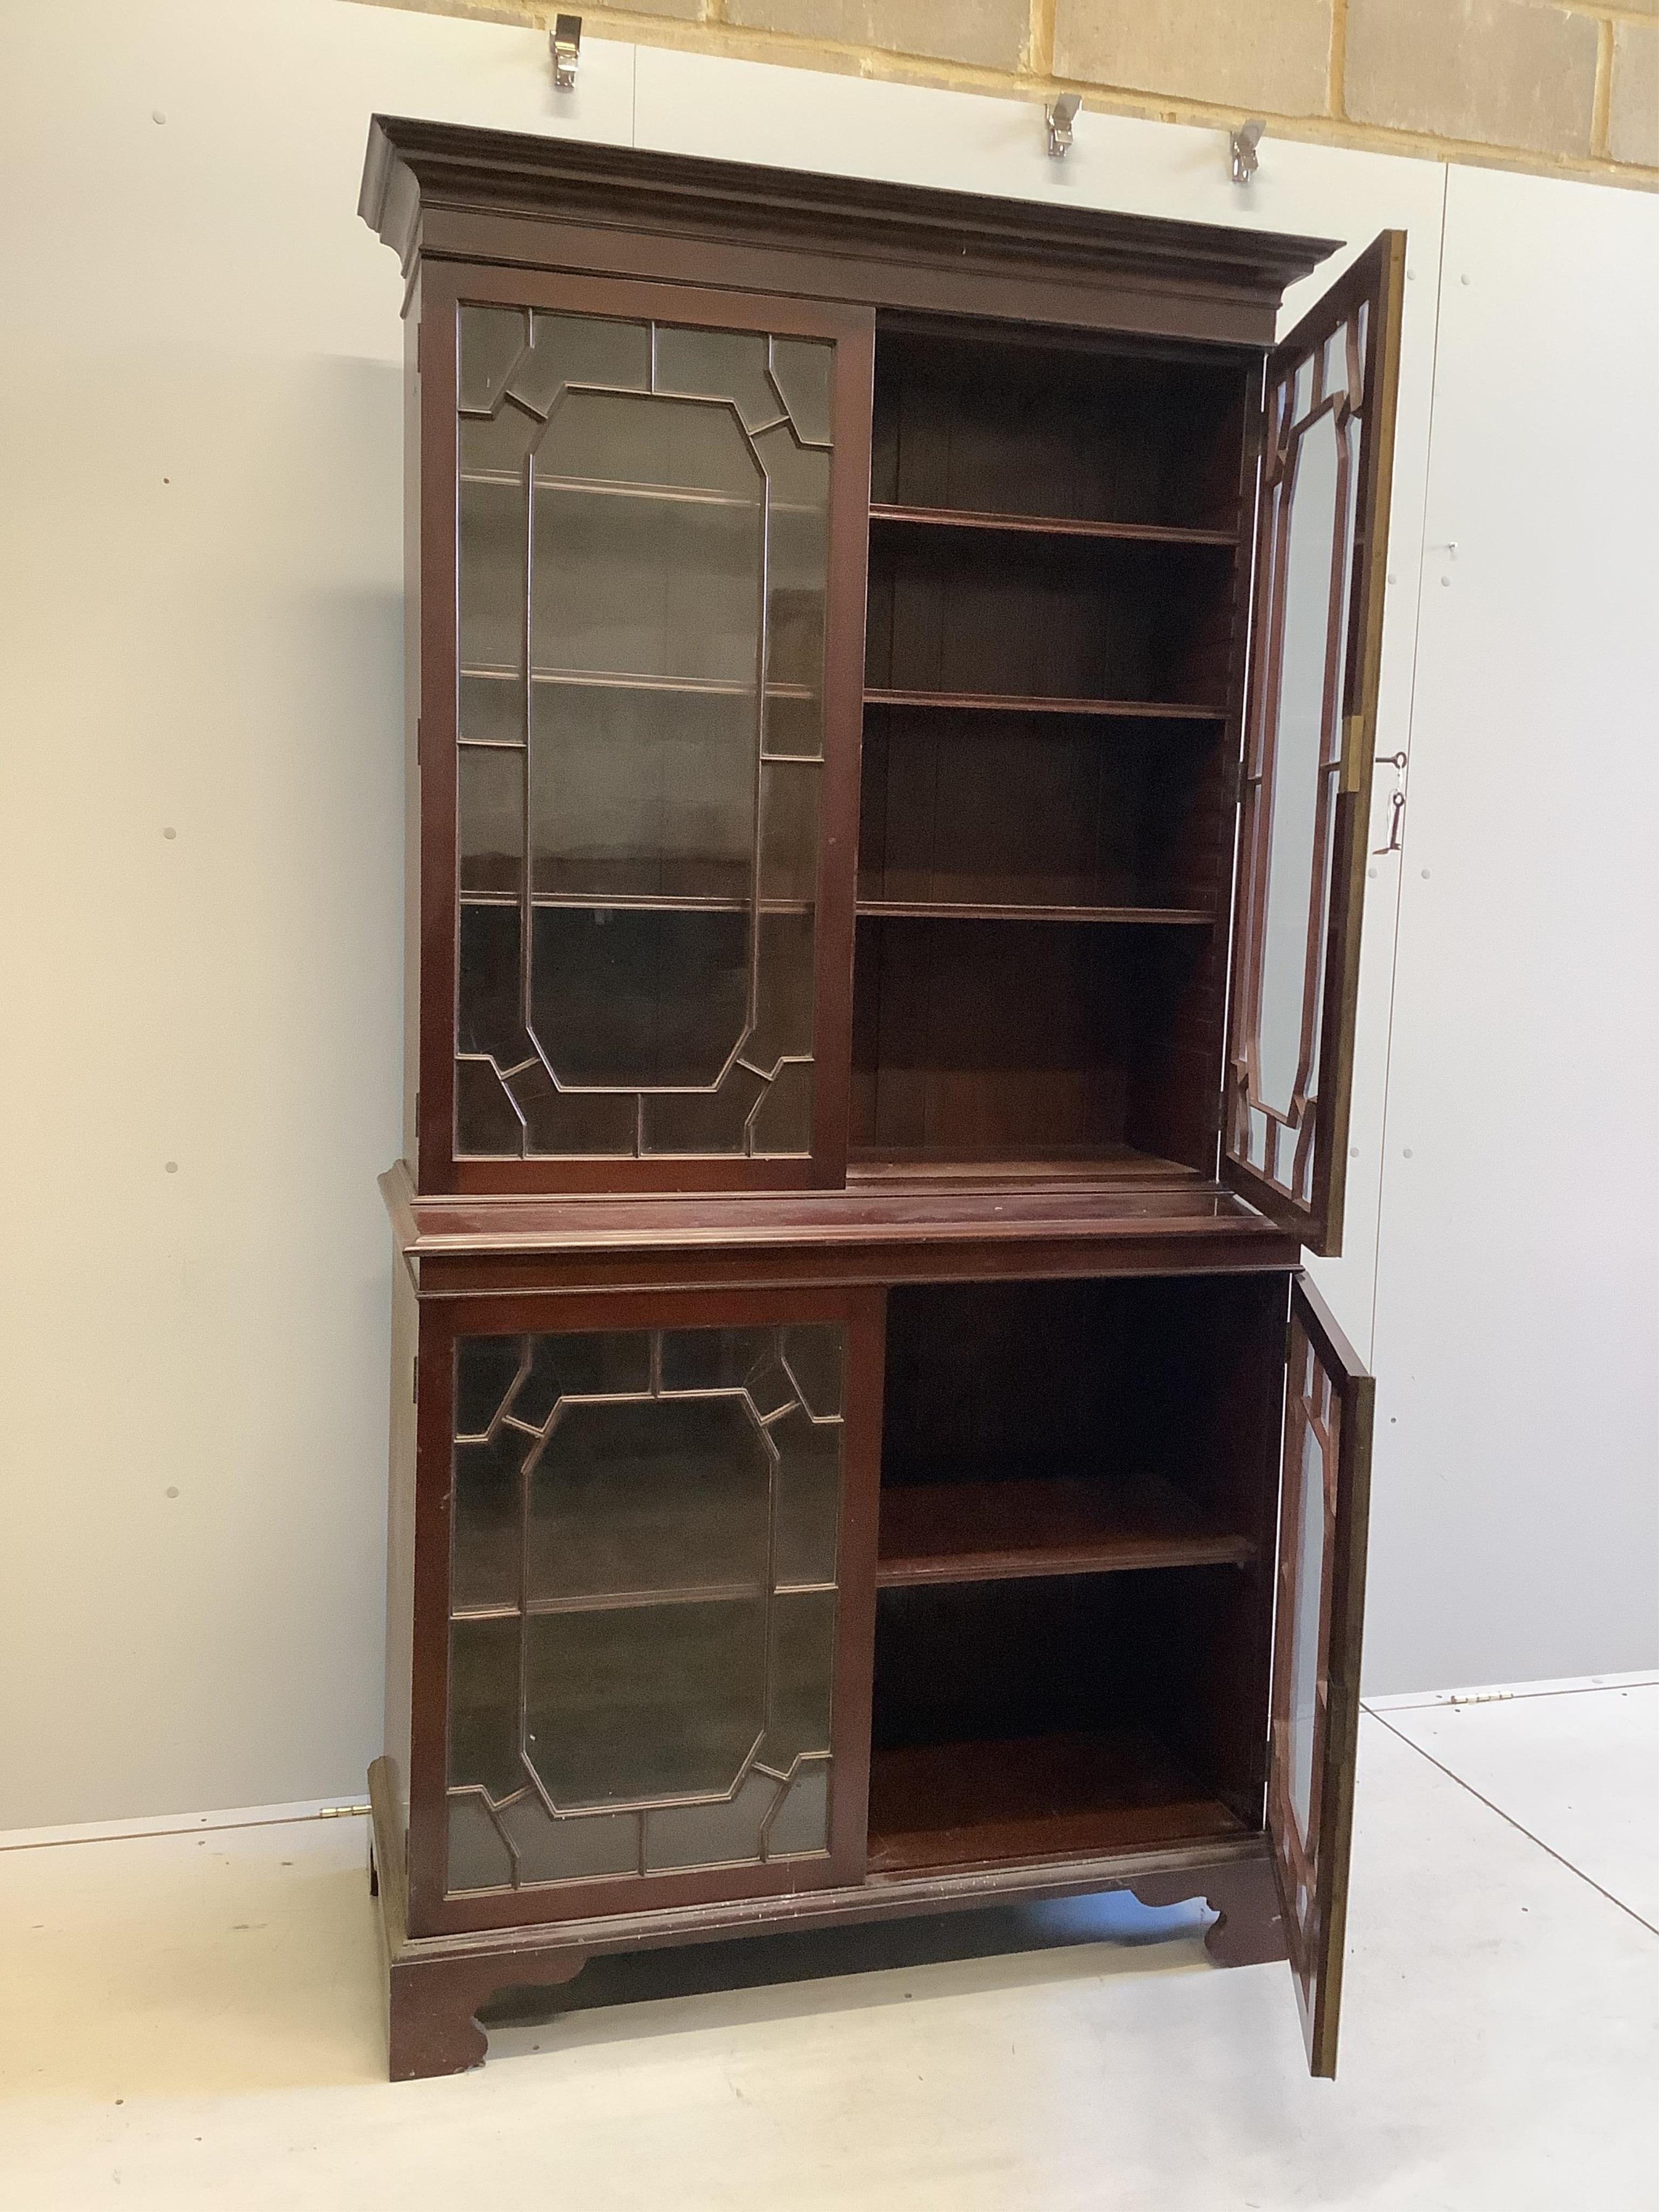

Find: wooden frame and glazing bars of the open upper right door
1221;230;1405;1257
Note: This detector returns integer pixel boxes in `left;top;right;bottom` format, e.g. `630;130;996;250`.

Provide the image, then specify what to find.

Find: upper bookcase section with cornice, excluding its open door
363;122;1325;1195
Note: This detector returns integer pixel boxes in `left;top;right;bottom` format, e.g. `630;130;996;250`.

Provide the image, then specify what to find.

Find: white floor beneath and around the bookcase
0;1683;1659;2212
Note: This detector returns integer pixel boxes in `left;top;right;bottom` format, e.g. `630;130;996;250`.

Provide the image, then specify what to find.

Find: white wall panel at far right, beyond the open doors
1367;168;1659;1690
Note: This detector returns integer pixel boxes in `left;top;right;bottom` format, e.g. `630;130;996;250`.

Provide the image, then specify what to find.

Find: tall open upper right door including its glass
1221;230;1405;1254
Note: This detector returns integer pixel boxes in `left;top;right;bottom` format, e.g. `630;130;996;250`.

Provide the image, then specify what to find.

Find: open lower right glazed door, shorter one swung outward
1267;1274;1376;2075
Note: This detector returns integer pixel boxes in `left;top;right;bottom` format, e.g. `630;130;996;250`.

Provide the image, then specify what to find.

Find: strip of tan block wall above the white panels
369;0;1659;190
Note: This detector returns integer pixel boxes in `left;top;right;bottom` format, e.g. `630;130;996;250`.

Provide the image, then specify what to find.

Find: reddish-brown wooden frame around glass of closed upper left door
407;257;876;1192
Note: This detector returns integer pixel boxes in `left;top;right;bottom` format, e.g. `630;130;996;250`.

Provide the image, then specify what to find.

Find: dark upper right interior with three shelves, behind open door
852;327;1259;1179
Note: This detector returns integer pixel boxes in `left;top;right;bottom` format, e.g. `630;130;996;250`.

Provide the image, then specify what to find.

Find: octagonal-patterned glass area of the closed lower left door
447;1323;845;1893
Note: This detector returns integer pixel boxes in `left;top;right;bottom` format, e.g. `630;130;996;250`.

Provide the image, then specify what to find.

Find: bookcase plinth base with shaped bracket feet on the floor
369;1758;1285;2081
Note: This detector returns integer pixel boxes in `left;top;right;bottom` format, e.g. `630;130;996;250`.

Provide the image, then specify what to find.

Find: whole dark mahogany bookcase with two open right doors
361;117;1405;2077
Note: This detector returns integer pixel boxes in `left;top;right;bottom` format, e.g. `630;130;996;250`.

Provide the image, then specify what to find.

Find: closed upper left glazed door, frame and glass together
418;263;874;1190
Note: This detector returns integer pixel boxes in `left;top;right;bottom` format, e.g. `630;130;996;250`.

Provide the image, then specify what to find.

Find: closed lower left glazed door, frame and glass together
409;1290;882;1933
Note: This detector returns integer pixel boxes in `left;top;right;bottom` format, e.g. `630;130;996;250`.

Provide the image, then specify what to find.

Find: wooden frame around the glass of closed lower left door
407;1287;887;1936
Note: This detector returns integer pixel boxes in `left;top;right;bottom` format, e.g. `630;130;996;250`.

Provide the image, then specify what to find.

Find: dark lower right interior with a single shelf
869;1276;1285;1873
